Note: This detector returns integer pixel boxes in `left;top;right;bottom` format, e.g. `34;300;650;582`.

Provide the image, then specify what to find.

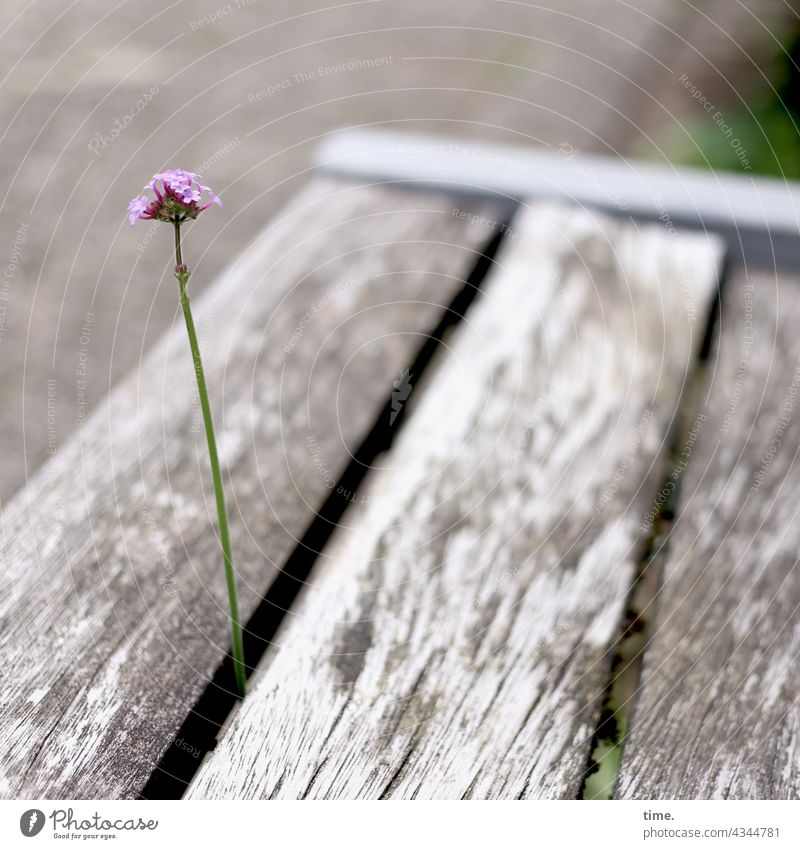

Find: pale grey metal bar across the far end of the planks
316;129;800;235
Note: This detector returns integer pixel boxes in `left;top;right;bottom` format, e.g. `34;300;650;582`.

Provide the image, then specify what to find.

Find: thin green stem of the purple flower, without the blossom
175;221;246;698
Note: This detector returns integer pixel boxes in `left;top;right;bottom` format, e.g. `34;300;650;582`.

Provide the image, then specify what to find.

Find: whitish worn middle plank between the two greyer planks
188;205;717;798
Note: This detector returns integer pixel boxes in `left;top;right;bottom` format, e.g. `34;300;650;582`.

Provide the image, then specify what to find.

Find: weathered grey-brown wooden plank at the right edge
617;274;800;799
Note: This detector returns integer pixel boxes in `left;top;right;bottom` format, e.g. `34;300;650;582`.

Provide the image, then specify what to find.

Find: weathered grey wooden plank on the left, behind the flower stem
0;180;500;798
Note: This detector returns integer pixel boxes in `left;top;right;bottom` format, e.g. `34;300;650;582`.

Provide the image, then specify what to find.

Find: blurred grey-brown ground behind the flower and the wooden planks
0;0;797;501
